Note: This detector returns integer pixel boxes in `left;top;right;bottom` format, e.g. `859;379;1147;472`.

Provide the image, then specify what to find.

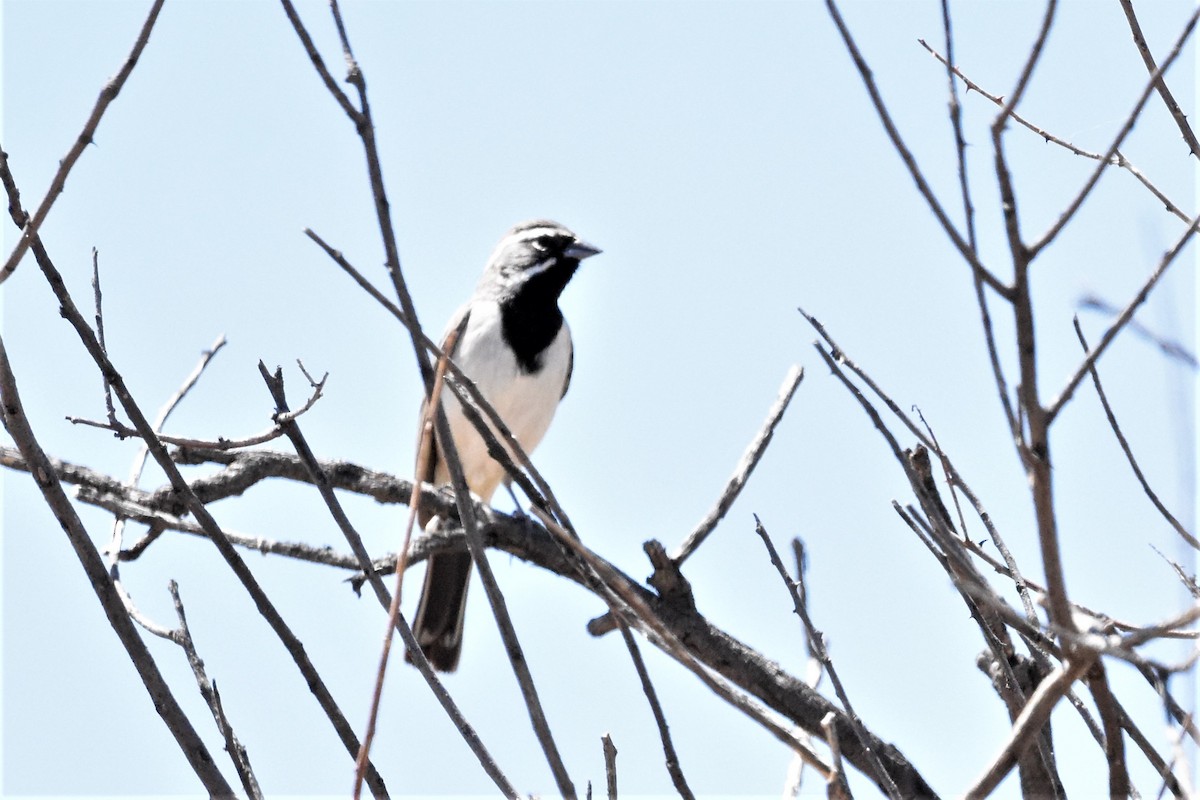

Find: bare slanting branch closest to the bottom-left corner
0;337;233;796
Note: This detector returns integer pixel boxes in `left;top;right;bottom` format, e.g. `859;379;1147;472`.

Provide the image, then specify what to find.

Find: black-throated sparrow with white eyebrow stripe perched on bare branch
408;219;600;672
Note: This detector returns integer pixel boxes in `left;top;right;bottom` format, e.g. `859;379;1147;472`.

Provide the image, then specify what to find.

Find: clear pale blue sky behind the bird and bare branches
0;0;1195;796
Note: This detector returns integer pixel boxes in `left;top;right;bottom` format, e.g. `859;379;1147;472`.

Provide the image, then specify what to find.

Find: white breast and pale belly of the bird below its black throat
434;301;571;503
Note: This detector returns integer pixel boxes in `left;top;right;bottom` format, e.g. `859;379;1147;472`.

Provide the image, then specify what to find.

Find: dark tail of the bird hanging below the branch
404;553;470;672
